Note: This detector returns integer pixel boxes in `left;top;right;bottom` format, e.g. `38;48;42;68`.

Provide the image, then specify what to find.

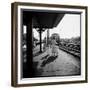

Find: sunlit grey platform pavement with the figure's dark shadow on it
33;46;80;76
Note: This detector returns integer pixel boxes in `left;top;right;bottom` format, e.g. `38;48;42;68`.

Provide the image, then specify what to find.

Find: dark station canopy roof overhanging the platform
23;11;65;29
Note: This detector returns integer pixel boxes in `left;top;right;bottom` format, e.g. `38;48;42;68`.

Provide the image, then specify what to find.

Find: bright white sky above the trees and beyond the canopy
33;14;80;39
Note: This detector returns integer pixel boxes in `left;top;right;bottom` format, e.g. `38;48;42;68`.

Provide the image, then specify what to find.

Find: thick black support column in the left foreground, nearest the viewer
27;21;34;77
